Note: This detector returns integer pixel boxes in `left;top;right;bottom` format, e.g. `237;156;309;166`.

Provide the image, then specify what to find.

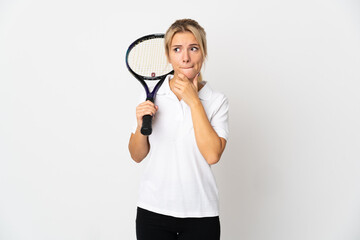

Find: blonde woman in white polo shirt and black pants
129;19;228;240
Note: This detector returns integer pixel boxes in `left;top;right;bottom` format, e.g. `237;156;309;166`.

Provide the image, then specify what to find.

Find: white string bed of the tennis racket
128;38;172;77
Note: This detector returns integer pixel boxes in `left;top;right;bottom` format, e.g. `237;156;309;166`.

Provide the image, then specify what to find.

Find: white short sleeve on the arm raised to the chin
210;95;229;140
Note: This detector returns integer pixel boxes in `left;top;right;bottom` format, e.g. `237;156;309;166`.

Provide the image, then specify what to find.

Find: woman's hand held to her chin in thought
173;73;199;107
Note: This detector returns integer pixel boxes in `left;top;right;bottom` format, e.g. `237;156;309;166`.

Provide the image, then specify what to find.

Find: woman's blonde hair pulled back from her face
165;19;207;60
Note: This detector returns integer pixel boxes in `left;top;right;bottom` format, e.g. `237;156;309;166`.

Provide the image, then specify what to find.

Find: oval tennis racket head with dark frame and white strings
125;33;174;81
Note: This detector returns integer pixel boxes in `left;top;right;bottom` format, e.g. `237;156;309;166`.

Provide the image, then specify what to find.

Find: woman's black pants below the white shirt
136;208;220;240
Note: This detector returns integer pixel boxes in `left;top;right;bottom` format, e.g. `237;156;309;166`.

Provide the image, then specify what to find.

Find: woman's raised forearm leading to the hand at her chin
190;100;225;164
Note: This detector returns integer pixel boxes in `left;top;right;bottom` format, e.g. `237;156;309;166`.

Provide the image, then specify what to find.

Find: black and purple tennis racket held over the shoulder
126;34;174;136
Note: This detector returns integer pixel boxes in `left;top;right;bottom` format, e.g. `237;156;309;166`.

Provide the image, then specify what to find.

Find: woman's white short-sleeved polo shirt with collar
133;75;229;217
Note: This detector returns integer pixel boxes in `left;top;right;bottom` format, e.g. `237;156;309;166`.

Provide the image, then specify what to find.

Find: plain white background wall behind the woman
0;0;360;240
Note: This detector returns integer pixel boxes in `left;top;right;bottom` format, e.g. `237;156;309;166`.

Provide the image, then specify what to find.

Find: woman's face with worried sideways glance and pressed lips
169;32;203;80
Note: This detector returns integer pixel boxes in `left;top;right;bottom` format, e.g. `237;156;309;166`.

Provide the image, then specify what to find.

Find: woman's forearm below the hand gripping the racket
129;129;150;163
